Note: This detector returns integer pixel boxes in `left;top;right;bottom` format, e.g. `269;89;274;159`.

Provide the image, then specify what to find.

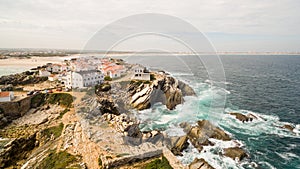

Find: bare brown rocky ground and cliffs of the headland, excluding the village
0;66;249;169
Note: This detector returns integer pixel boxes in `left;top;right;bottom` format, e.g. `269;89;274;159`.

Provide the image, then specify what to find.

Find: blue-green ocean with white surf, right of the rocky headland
125;55;300;169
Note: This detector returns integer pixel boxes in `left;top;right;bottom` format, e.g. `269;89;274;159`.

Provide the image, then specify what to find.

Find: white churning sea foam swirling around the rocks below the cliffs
138;78;300;168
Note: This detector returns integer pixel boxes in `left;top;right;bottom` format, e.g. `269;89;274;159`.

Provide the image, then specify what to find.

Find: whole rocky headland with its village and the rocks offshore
0;53;292;169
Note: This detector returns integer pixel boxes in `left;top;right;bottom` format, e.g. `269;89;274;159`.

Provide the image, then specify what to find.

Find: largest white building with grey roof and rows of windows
63;70;104;88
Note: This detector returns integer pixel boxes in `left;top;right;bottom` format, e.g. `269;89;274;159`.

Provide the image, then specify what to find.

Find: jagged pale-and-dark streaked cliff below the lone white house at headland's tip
128;75;195;110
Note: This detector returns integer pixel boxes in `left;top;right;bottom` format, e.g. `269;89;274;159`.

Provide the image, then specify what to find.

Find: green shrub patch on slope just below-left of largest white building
47;93;73;107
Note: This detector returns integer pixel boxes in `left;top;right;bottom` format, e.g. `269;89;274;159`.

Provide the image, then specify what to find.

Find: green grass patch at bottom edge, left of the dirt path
37;150;78;169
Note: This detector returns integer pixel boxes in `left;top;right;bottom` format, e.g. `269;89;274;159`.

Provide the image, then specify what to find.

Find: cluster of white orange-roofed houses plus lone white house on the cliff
39;57;150;89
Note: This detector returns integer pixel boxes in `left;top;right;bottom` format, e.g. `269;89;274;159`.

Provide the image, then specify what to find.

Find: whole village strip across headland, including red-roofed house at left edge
0;57;150;101
